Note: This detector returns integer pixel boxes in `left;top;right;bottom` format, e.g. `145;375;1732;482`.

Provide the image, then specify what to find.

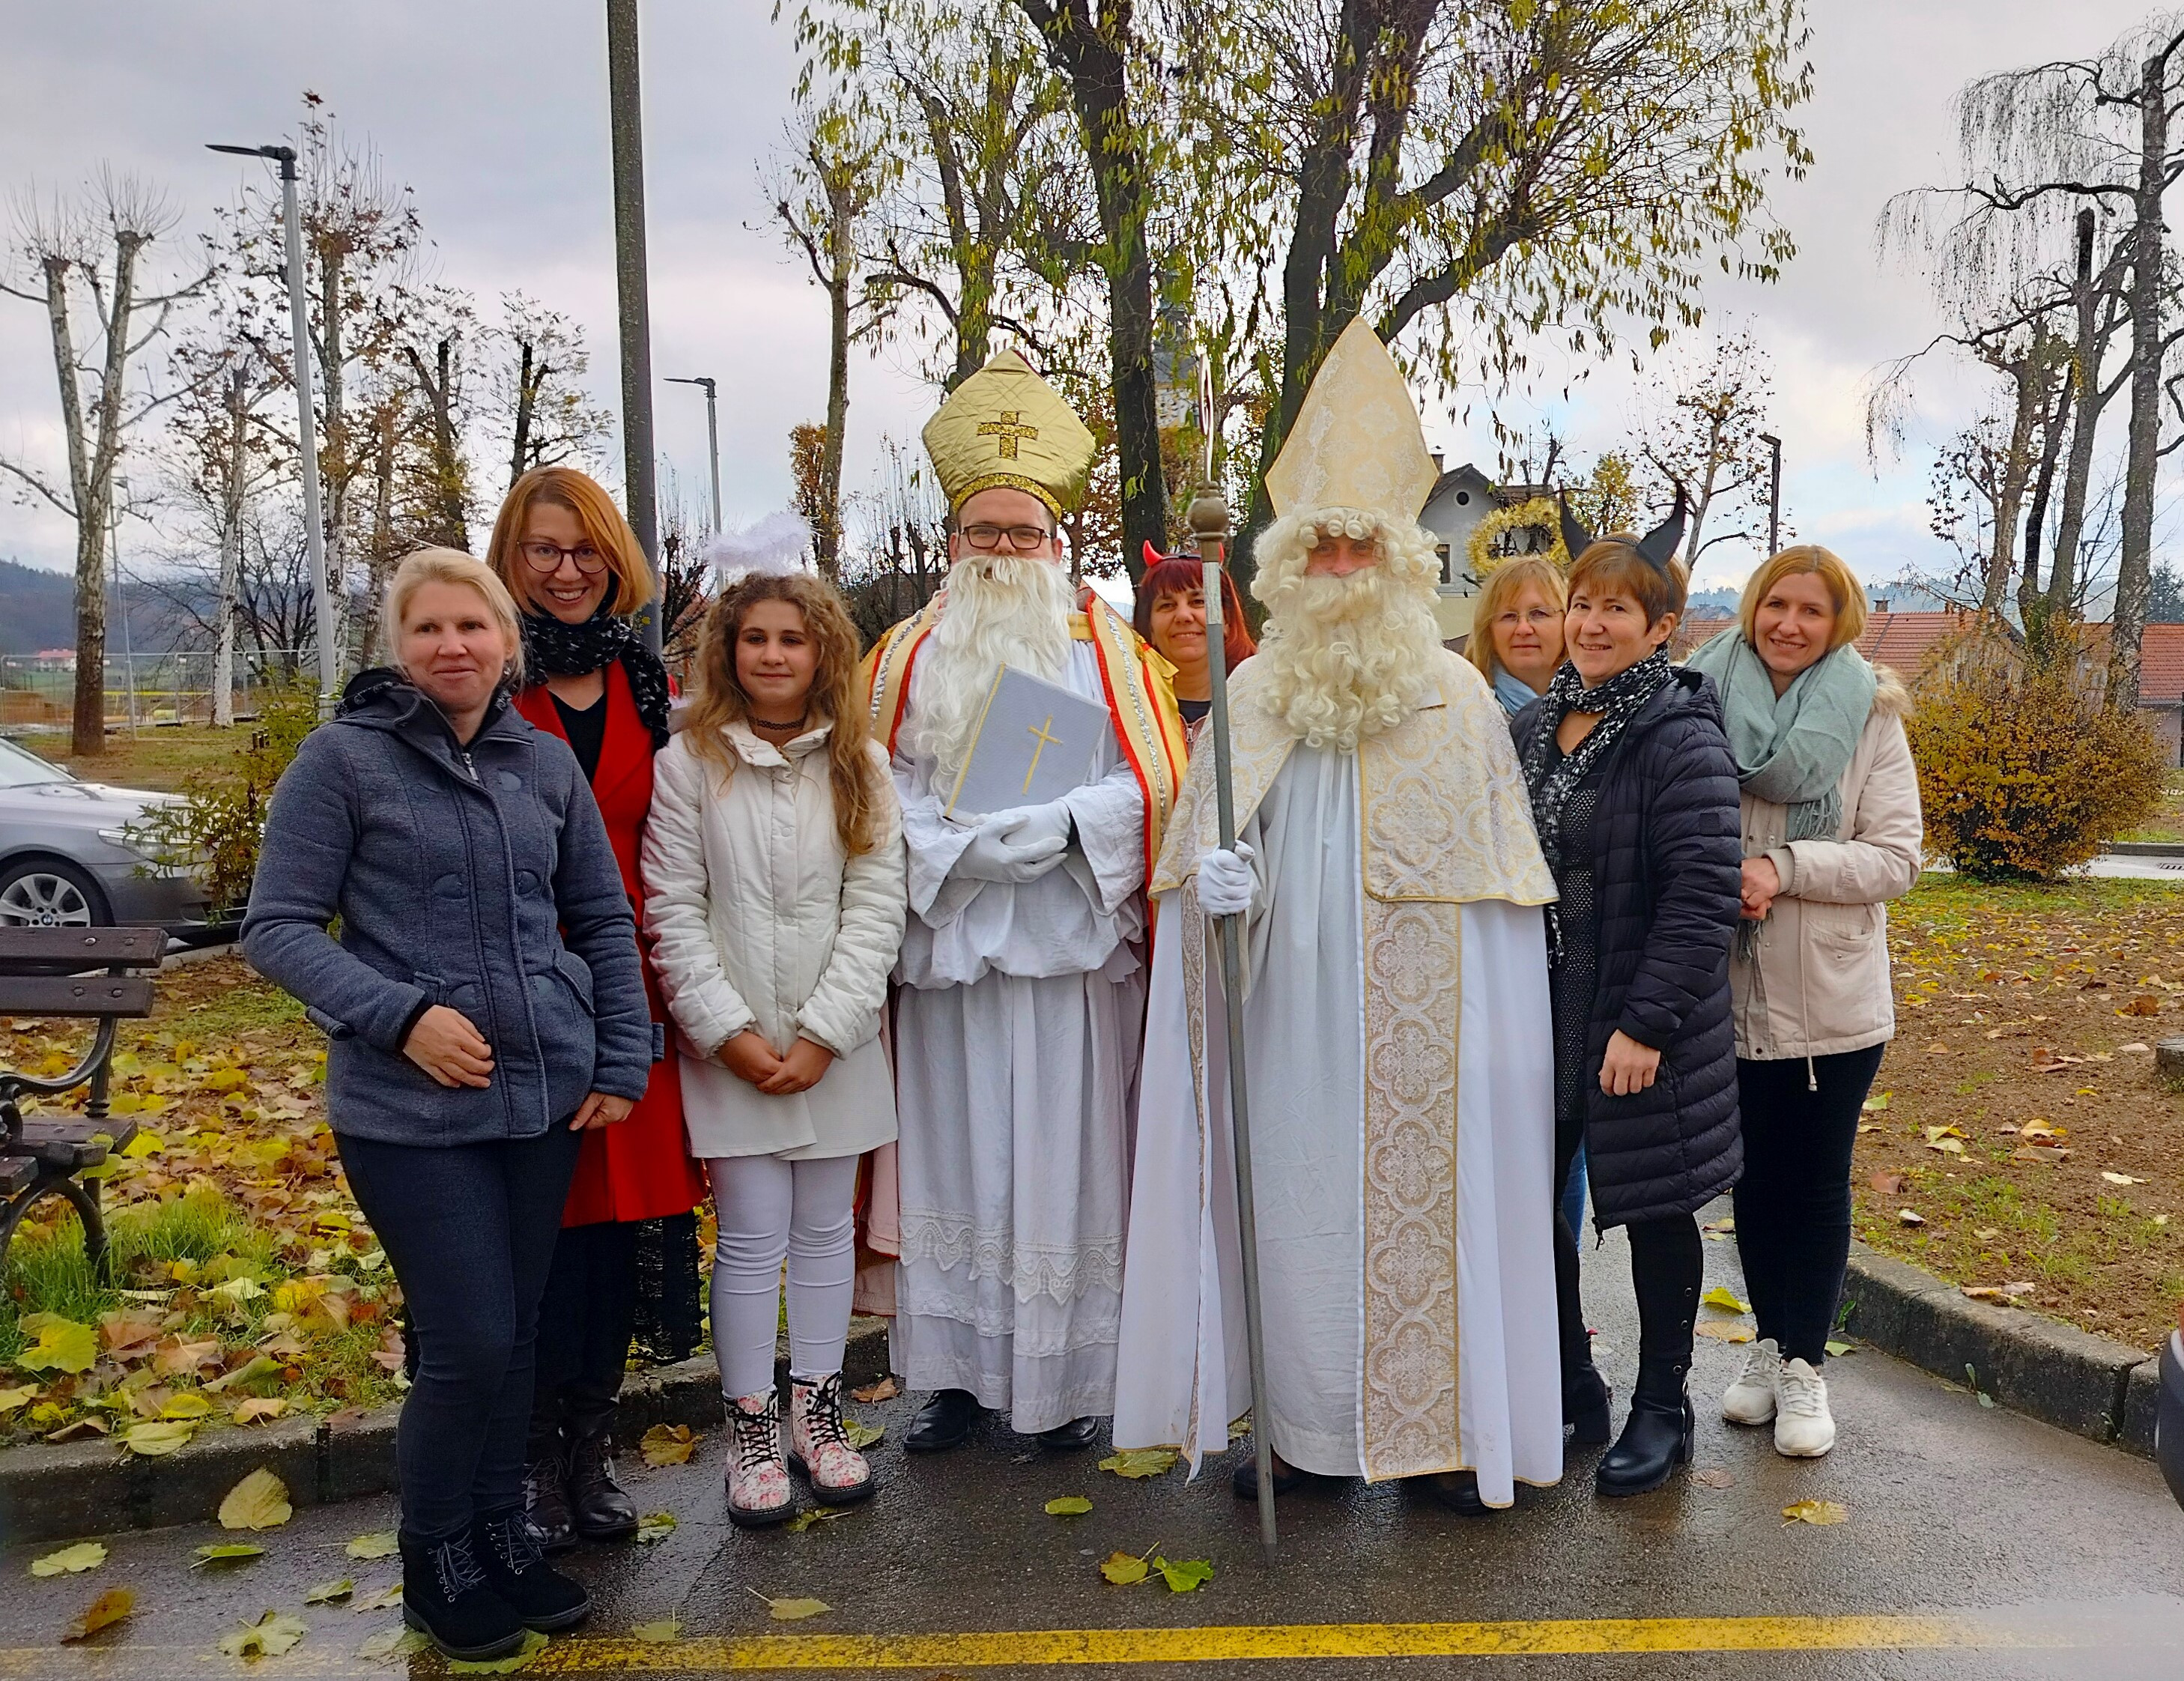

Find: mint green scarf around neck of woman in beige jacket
1686;626;1878;840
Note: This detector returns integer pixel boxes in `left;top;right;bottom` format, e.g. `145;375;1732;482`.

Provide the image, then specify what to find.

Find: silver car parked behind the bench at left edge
0;738;205;934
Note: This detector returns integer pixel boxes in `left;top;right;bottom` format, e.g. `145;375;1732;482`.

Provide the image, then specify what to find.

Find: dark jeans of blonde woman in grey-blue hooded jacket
336;1127;579;1541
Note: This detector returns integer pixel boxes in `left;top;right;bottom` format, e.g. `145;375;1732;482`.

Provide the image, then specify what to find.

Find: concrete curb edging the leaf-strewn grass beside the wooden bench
0;1318;887;1545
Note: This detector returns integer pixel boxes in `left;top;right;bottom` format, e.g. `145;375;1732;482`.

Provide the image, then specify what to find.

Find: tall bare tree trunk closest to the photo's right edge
2108;52;2169;712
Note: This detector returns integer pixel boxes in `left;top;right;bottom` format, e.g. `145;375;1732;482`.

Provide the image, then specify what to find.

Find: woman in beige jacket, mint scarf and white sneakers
1690;544;1924;1459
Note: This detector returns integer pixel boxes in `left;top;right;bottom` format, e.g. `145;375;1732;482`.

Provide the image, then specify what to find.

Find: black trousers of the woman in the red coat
531;1220;637;1459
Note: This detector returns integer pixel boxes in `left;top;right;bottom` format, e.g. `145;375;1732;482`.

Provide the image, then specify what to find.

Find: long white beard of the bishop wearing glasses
909;543;1077;797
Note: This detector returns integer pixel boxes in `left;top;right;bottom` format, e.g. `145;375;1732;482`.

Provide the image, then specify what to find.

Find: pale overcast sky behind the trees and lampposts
0;0;2175;581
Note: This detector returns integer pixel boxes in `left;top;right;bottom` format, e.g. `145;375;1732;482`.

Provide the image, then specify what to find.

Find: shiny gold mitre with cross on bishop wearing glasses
923;349;1099;520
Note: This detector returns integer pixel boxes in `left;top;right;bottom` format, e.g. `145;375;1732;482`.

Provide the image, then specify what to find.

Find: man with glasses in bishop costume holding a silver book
871;349;1183;1454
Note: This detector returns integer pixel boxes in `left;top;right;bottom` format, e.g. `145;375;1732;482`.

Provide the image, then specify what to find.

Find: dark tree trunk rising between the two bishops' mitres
1018;0;1162;583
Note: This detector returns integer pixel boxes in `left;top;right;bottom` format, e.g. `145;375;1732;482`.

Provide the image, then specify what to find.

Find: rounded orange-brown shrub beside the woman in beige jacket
1909;664;2167;882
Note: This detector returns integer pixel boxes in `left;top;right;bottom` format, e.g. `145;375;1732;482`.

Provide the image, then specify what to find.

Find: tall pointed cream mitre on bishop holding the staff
1267;321;1440;526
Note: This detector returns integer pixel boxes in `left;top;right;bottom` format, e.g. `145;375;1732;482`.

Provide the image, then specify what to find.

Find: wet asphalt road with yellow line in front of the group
0;1205;2184;1681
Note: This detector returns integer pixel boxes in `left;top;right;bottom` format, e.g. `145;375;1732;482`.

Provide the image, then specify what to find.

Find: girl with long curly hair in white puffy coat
644;572;906;1526
